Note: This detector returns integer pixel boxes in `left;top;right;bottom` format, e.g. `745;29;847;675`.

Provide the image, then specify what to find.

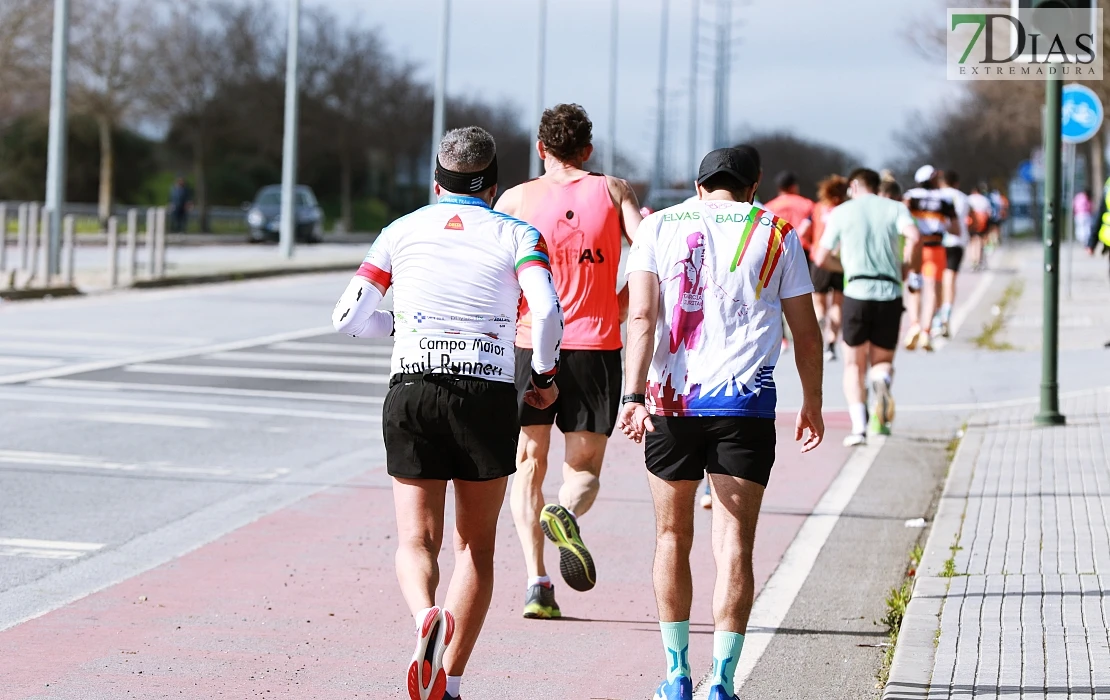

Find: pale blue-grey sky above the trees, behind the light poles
295;0;955;171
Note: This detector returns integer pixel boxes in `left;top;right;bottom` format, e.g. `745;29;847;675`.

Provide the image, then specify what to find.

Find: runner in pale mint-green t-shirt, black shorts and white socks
814;169;920;447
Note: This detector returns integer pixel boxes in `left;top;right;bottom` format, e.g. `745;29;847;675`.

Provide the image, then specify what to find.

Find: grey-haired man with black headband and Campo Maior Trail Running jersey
332;126;563;700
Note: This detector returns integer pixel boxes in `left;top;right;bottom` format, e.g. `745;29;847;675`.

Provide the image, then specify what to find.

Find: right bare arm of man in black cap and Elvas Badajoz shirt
781;294;825;453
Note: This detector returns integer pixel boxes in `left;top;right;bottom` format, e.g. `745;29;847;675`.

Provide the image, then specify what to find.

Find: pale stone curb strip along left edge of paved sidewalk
882;427;983;700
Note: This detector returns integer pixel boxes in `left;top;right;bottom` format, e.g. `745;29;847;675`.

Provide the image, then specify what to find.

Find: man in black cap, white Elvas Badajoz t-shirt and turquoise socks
619;149;825;700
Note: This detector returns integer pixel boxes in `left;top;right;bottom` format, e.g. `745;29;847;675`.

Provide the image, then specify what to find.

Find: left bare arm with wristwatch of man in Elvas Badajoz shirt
617;272;657;443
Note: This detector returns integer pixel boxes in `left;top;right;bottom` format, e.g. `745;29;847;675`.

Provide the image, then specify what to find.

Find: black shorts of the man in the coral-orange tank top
516;347;620;436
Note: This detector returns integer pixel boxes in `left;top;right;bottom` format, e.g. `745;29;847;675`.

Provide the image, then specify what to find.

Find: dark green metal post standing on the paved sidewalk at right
1033;75;1064;426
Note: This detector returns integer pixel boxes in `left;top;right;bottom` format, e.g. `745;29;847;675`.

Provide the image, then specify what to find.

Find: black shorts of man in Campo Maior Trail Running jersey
382;374;521;481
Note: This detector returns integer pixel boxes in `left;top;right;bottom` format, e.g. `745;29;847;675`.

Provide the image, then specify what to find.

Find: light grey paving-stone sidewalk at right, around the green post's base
884;389;1110;700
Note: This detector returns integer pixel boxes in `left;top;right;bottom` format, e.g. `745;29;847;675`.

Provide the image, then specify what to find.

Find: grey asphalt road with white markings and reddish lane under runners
0;245;1108;699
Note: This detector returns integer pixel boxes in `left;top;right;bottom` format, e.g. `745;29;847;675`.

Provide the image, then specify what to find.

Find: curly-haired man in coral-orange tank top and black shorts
496;104;642;619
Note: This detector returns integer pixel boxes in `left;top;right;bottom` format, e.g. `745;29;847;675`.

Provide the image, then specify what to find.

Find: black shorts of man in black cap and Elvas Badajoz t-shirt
644;416;776;486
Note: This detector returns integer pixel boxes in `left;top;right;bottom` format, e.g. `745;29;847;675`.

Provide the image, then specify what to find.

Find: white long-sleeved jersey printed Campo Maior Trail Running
332;195;563;383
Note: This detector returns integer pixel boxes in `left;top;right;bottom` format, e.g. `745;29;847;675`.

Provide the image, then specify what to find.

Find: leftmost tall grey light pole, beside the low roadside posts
47;0;69;277
